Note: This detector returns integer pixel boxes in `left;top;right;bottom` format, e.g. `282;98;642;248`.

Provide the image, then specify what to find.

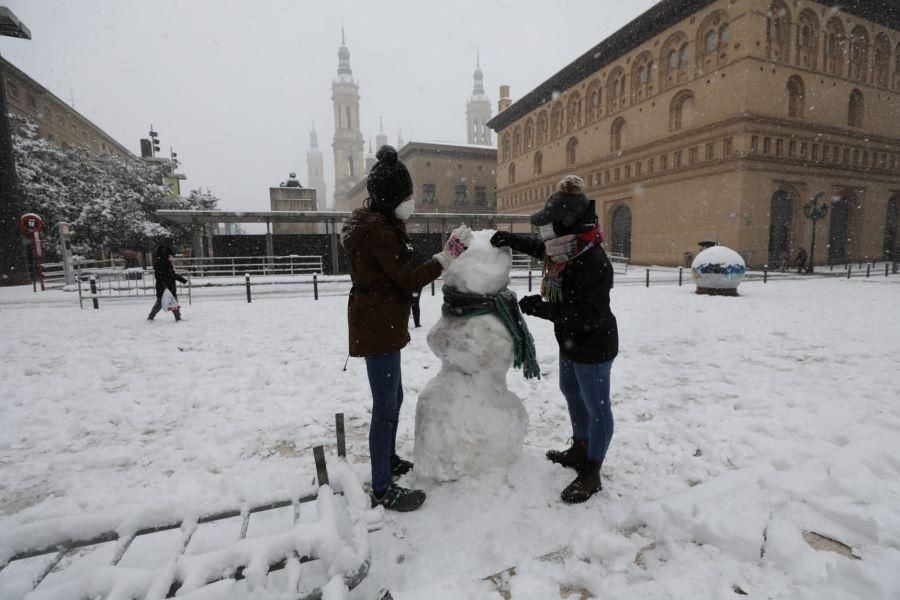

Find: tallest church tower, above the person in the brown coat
331;27;365;210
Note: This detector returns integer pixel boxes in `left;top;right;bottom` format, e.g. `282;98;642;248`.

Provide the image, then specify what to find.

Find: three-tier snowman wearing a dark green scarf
415;230;539;481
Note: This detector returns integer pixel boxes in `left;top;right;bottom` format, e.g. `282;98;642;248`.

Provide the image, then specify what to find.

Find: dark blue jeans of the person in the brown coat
366;351;403;491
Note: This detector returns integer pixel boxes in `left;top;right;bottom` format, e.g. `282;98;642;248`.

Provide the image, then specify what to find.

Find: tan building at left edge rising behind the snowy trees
0;58;134;158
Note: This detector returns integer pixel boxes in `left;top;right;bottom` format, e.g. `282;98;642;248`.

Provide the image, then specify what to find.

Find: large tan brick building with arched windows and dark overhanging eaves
488;0;900;266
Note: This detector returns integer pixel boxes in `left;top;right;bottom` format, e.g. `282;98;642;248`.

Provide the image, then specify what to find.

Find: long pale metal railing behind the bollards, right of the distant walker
173;254;323;277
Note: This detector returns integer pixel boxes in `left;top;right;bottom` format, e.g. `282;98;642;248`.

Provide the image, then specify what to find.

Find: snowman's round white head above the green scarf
444;229;512;296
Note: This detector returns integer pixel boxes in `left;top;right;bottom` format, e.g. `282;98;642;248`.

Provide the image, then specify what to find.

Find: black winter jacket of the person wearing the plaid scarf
510;235;619;363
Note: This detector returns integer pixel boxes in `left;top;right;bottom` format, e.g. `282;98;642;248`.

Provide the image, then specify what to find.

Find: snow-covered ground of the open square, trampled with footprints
0;276;900;600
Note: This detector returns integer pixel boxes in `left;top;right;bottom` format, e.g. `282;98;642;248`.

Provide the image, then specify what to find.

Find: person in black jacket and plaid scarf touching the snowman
491;175;619;504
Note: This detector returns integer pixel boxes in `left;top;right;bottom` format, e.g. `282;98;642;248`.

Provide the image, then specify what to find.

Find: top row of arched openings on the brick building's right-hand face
768;0;900;91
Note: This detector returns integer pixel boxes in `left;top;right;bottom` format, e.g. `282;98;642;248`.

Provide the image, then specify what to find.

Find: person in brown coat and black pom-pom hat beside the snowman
341;146;472;511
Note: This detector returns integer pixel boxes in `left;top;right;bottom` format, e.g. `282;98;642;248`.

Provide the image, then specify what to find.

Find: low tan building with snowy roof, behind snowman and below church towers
347;142;497;232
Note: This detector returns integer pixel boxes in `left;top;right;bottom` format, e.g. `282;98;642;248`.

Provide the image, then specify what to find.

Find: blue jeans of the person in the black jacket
559;353;613;463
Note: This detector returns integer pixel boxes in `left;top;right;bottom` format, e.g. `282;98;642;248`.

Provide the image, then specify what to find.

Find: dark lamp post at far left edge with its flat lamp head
0;6;31;285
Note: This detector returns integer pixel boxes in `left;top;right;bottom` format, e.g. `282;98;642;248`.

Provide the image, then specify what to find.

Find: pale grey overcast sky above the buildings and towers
0;0;656;210
